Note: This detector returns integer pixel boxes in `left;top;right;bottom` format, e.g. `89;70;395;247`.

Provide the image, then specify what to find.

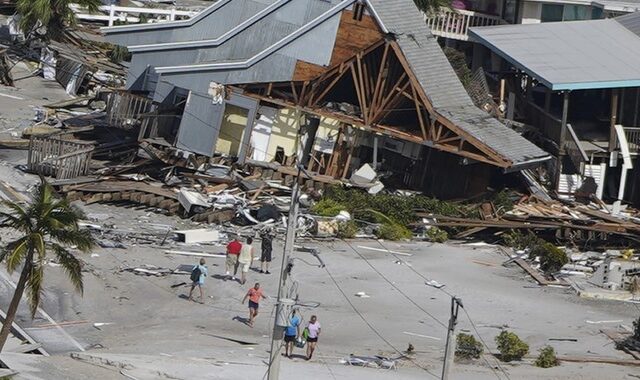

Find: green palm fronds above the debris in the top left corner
16;0;102;39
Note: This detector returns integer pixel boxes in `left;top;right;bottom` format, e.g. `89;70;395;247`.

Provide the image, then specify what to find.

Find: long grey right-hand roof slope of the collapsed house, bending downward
370;0;549;166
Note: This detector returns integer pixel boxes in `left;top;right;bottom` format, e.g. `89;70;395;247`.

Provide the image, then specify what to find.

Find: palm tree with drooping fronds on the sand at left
0;178;95;351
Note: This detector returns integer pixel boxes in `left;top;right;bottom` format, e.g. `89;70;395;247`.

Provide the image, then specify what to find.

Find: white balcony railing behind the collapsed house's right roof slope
425;8;504;41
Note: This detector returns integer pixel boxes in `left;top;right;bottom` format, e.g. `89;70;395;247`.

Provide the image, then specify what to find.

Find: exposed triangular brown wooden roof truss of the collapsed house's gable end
238;39;511;167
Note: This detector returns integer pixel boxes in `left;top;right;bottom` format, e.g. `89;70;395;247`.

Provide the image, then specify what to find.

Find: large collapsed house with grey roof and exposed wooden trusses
103;0;550;198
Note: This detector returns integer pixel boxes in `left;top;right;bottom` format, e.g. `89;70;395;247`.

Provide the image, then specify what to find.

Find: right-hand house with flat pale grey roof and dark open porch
470;13;640;205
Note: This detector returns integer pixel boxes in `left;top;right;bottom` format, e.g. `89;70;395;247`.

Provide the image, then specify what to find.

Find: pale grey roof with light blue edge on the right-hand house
470;15;640;90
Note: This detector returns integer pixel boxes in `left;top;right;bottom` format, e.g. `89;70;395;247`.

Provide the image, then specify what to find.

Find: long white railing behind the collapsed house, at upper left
69;4;198;26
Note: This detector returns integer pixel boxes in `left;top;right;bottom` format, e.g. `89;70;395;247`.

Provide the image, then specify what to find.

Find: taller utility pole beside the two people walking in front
267;114;320;380
